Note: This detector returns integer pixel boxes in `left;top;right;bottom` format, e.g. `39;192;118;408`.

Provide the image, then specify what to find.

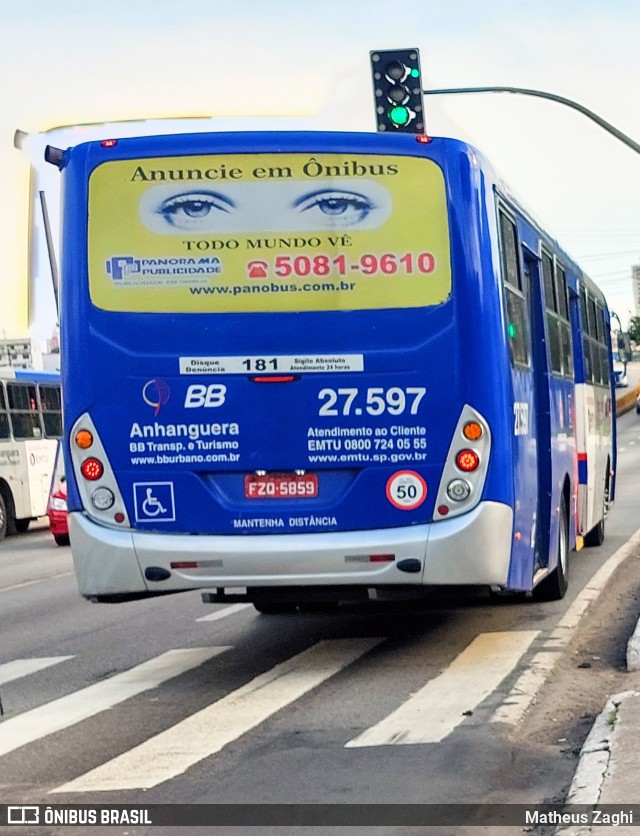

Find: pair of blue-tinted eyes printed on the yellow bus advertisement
139;179;392;235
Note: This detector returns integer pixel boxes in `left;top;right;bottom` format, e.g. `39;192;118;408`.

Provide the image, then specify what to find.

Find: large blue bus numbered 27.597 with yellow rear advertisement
46;132;616;613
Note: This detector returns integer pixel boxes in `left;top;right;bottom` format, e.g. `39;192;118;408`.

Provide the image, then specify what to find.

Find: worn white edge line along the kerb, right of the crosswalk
491;528;640;726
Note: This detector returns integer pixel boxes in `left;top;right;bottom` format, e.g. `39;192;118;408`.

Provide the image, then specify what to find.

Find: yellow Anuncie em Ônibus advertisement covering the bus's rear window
88;154;451;313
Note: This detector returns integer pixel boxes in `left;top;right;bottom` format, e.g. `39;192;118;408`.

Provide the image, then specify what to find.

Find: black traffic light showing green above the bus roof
369;49;424;134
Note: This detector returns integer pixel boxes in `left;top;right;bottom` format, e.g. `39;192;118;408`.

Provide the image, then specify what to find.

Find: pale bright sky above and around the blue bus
0;0;640;340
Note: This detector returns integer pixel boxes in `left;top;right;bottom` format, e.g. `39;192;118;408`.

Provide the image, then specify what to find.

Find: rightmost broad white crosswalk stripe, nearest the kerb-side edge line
346;630;539;748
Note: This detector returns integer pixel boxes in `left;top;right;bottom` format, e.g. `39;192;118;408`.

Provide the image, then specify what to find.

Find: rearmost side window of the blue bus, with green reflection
499;210;529;367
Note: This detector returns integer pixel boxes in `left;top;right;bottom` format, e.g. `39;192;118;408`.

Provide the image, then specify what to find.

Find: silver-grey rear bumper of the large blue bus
69;502;513;597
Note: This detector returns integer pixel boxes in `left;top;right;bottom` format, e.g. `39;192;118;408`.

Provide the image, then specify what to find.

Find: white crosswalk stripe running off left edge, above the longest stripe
0;647;231;756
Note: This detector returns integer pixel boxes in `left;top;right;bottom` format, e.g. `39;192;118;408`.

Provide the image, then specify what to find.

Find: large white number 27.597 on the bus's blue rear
318;386;426;415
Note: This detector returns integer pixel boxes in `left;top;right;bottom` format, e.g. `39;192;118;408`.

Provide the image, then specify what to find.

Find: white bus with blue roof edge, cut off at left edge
0;369;62;541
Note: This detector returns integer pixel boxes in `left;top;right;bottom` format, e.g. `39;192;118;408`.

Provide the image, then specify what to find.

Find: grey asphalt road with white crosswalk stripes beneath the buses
0;412;640;836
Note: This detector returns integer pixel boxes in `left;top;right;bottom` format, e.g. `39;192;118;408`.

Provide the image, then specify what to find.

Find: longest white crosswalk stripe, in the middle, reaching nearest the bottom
51;638;384;793
